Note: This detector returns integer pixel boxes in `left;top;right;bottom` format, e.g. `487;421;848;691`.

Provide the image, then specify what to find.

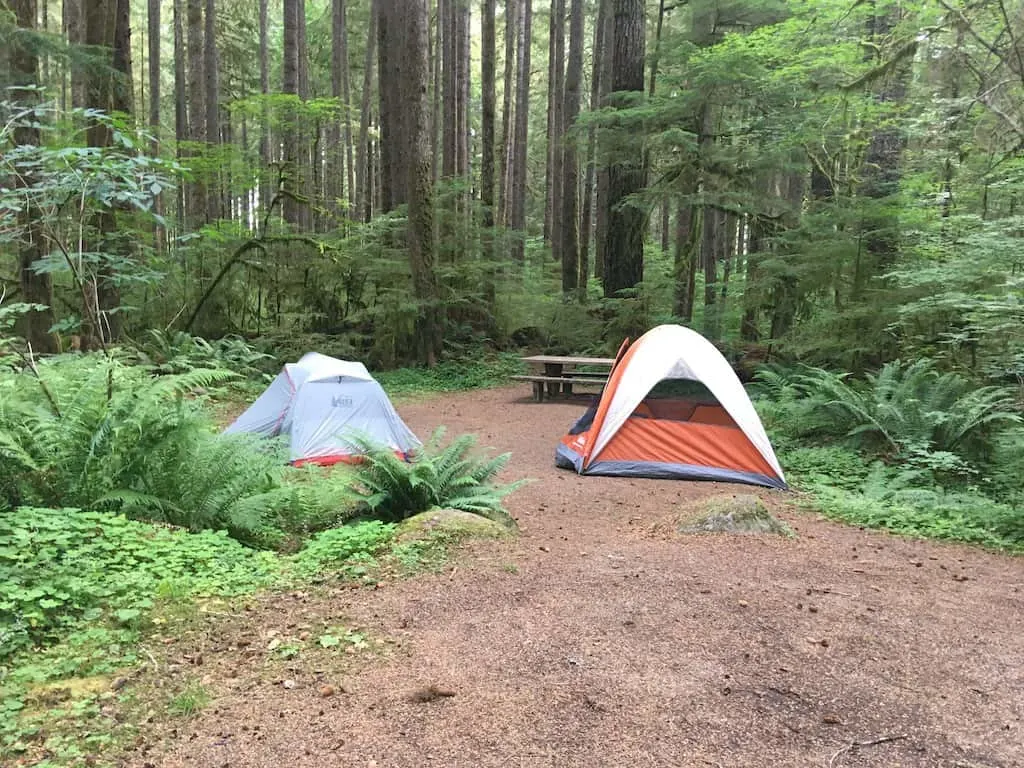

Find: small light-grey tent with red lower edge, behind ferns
224;352;421;466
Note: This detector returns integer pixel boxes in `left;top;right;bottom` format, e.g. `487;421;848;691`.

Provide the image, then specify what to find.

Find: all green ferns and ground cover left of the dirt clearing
0;344;518;765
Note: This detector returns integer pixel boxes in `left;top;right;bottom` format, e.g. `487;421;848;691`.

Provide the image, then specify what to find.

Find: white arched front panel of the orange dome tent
590;326;785;481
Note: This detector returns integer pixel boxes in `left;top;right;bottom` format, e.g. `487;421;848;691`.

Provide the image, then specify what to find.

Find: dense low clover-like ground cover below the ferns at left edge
0;507;280;658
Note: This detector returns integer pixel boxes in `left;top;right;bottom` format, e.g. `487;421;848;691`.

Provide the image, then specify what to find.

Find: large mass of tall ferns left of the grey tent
0;356;345;546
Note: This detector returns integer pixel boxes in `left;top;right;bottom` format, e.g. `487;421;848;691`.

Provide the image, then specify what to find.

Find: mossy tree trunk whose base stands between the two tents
395;0;443;366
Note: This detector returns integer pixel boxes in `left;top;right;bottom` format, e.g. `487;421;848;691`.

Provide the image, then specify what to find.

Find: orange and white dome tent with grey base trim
555;326;787;488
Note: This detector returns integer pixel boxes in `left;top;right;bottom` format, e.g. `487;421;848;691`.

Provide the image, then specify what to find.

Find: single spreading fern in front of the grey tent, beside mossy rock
346;427;522;527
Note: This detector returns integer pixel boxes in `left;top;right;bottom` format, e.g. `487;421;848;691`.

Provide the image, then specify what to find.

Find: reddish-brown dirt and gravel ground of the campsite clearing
127;387;1024;768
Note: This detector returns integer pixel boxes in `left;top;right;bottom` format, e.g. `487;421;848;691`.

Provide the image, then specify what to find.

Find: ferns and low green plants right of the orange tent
754;359;1024;550
